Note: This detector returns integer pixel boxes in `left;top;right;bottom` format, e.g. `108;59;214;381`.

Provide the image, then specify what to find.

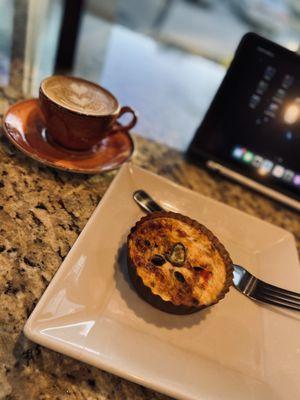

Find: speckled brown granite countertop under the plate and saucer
0;89;300;400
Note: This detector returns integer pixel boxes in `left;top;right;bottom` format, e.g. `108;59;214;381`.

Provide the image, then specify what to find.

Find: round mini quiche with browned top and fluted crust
127;212;233;314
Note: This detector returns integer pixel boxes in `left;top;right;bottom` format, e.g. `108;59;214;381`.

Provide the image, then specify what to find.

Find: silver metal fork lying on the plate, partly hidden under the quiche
133;190;300;311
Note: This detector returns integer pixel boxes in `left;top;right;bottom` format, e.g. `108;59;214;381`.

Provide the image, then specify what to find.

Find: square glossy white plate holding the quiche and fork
24;164;300;400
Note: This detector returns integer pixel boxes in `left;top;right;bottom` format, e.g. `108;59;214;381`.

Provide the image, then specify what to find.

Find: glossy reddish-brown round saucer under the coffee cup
3;99;134;174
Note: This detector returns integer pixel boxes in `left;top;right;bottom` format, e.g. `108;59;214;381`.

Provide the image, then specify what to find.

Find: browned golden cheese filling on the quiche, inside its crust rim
129;217;226;306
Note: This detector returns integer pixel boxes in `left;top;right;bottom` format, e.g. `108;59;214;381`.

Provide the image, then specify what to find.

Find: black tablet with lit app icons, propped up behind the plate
187;33;300;210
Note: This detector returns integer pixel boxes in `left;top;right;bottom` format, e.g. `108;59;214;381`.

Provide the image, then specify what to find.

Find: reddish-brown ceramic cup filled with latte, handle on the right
39;75;137;150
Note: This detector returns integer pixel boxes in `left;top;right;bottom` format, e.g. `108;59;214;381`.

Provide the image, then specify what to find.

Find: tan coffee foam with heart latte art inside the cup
41;76;118;115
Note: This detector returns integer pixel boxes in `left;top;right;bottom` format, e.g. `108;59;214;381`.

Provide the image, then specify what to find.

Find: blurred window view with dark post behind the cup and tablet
0;0;300;149
